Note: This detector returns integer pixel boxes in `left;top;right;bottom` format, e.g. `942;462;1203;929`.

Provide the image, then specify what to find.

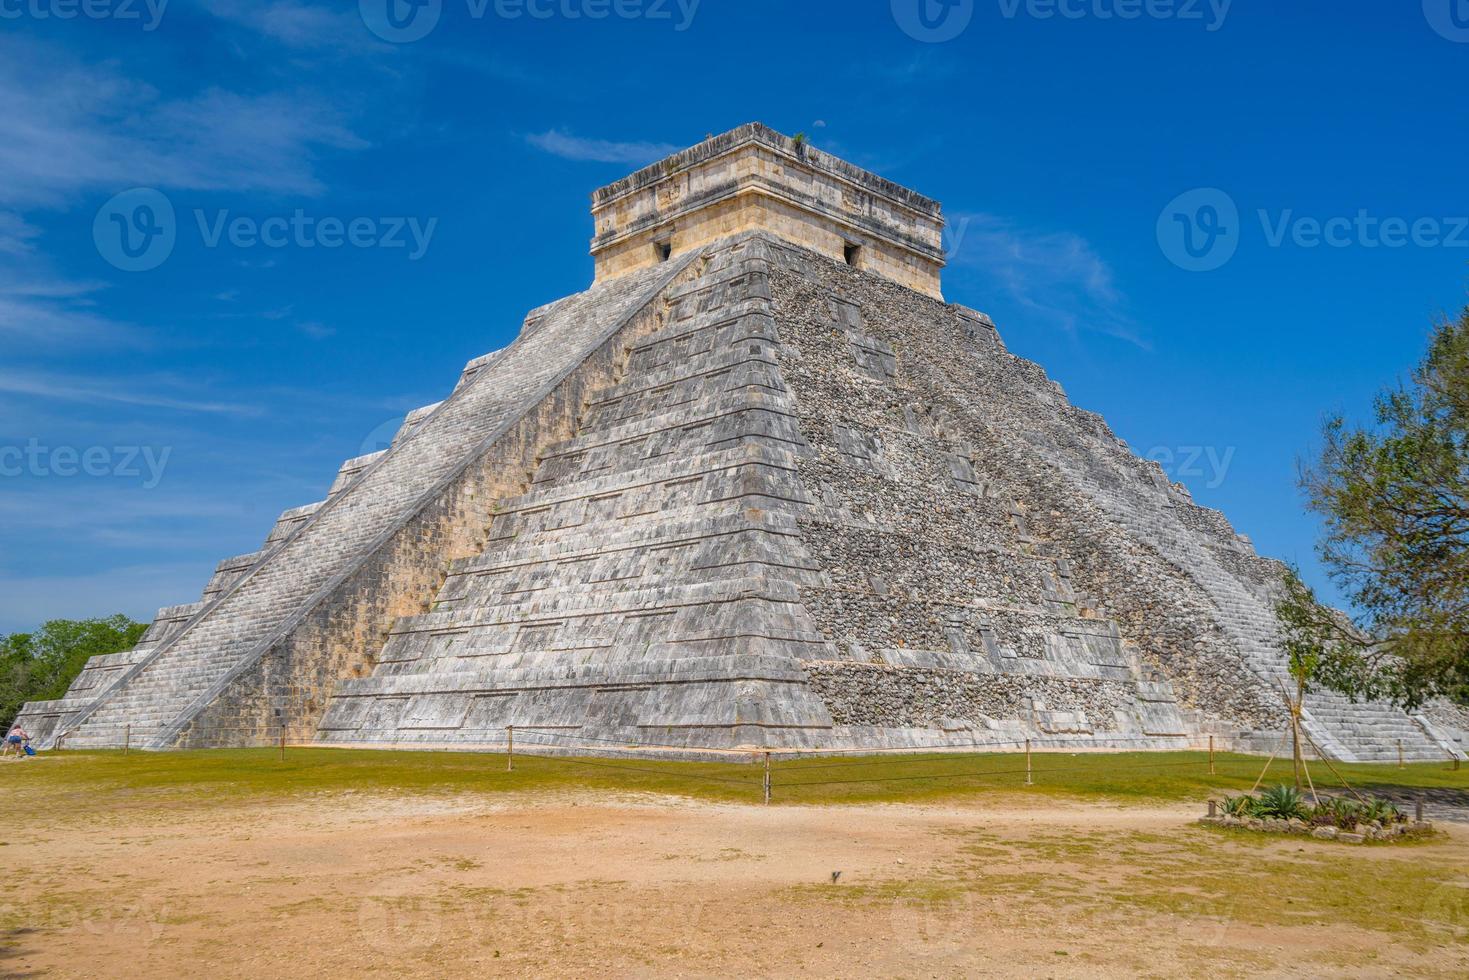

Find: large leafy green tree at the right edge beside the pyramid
1282;302;1469;708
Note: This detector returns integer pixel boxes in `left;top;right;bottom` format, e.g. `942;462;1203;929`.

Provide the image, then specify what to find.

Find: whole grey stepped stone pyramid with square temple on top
22;125;1469;760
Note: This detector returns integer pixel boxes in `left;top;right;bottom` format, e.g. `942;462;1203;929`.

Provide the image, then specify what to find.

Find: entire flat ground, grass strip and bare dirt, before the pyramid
0;748;1469;979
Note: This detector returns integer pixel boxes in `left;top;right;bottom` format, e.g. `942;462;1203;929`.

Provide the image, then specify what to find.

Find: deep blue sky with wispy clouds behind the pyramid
0;0;1469;630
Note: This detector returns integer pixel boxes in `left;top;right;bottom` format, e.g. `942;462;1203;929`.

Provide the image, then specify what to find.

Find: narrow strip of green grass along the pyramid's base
0;748;1469;813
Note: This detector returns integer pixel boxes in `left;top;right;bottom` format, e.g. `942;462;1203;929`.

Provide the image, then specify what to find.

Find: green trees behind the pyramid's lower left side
0;614;148;726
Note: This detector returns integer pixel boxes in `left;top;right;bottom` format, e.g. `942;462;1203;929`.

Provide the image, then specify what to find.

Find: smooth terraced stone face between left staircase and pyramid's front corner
319;239;852;745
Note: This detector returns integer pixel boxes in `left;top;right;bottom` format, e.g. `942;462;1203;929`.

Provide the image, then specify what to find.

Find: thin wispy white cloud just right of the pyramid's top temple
945;213;1149;350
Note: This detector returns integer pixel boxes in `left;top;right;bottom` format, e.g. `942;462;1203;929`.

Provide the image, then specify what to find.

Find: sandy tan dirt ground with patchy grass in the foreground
0;792;1469;977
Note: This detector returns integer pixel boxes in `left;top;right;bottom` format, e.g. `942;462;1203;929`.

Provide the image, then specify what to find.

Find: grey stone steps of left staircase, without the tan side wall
54;254;702;743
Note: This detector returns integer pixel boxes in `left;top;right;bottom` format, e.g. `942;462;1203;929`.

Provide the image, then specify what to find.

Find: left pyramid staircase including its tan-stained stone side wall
22;256;693;748
